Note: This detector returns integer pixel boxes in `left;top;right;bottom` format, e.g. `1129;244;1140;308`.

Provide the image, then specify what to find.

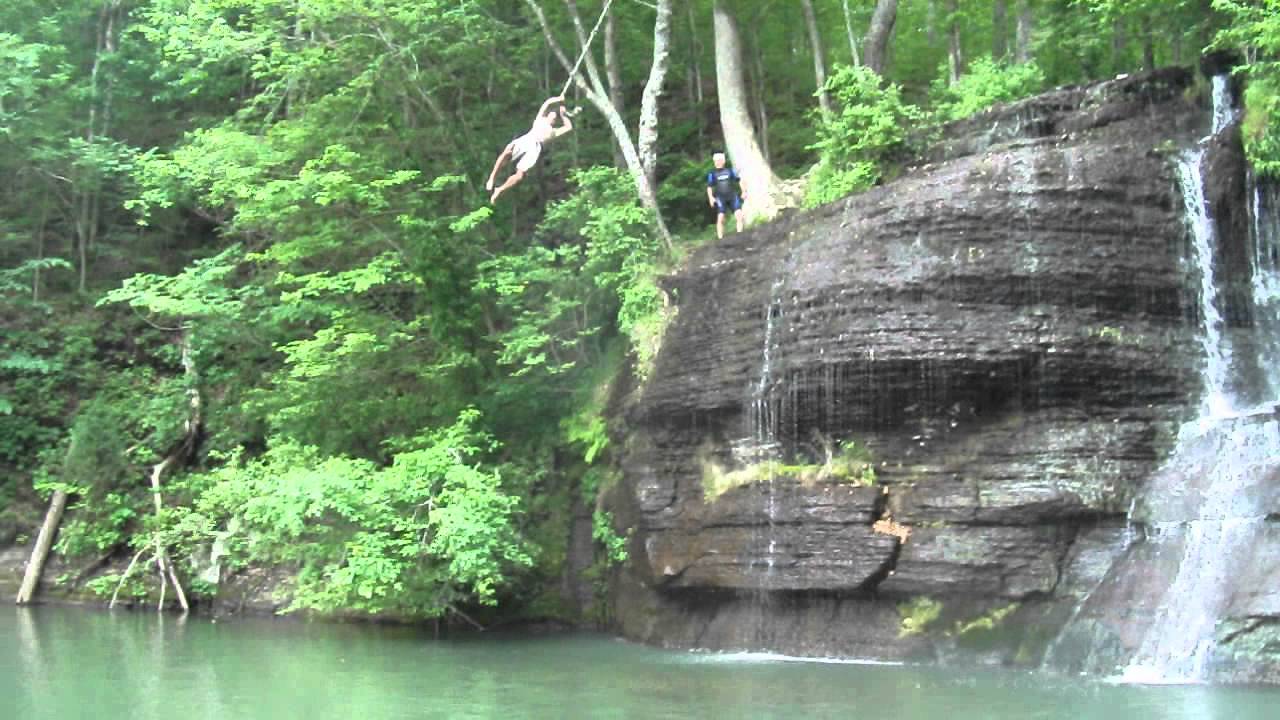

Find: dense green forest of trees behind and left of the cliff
0;0;1280;620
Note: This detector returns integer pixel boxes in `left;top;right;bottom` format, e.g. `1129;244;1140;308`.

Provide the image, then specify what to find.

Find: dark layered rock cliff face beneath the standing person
612;69;1274;662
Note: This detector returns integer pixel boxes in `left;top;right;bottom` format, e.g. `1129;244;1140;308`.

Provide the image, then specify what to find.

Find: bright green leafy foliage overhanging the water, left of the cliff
183;411;532;616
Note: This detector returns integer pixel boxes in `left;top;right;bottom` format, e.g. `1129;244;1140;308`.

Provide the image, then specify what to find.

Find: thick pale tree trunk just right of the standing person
714;0;778;218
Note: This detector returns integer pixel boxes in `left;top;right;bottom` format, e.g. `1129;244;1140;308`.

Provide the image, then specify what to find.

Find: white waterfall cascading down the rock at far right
1119;76;1280;683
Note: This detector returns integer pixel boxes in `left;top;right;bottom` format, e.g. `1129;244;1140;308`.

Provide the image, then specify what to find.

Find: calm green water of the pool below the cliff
0;609;1280;720
